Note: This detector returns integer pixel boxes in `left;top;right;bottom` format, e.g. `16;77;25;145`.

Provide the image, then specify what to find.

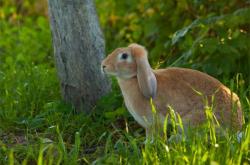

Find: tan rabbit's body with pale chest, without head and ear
118;68;242;130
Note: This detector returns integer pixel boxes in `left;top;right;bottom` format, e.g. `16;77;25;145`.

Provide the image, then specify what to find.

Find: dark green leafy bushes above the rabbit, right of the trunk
96;0;250;85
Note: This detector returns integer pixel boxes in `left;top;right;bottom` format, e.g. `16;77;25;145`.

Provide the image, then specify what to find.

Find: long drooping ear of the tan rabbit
129;44;157;99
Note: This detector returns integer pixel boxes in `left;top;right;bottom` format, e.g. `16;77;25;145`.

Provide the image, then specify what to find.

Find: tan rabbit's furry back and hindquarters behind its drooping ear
154;68;242;129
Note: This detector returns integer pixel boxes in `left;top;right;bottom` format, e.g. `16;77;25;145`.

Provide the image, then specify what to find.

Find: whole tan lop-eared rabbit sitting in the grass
101;43;242;137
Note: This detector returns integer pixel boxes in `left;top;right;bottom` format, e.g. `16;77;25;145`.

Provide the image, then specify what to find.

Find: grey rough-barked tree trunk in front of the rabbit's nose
48;0;110;112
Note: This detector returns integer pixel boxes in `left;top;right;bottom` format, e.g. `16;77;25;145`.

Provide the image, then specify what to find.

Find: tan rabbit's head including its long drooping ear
102;44;157;98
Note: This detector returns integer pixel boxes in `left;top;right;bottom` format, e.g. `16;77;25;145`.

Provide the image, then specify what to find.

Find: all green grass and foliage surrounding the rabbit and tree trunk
0;0;250;165
